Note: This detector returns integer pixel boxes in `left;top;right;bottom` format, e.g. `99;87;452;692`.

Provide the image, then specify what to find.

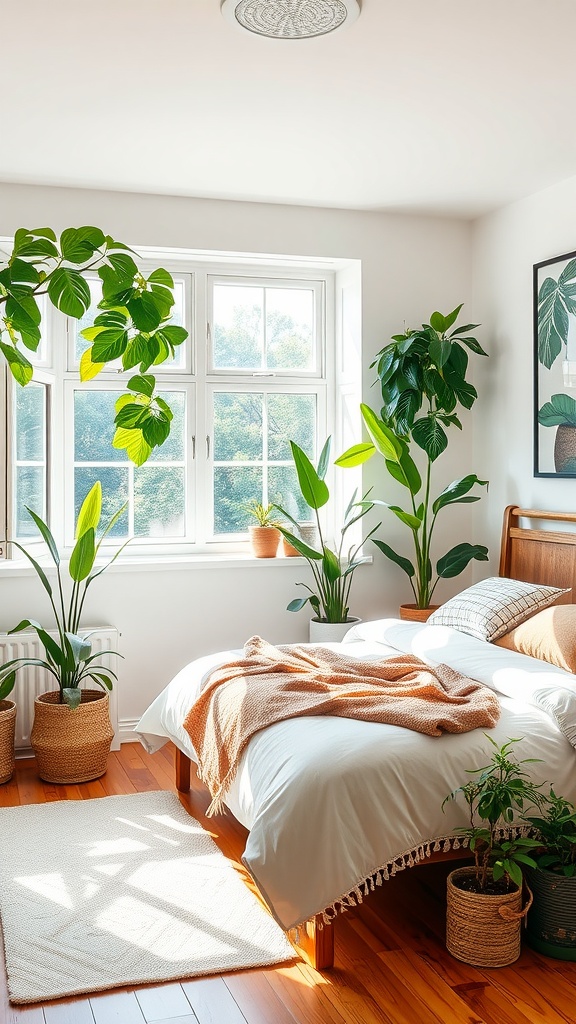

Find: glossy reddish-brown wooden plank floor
0;743;576;1024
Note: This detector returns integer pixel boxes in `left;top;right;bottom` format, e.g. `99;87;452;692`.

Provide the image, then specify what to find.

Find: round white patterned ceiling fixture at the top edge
221;0;360;39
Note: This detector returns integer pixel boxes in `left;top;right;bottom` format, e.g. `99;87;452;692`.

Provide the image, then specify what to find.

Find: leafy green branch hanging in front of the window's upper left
0;225;188;466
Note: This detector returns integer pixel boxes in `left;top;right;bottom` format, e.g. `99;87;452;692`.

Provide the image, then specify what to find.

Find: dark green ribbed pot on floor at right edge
526;869;576;961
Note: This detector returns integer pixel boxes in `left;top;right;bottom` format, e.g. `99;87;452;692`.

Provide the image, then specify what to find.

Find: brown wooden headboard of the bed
499;505;576;604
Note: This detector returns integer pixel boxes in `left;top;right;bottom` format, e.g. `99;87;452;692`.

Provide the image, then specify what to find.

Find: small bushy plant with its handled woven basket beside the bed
445;735;541;967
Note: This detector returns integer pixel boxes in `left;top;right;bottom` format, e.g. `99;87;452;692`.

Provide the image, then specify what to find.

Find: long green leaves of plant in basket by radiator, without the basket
0;481;125;710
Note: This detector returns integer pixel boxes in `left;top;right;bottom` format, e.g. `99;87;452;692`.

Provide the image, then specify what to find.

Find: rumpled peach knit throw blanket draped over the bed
183;637;500;814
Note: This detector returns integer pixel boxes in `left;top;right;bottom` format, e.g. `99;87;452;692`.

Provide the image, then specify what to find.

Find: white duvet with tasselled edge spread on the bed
136;620;576;930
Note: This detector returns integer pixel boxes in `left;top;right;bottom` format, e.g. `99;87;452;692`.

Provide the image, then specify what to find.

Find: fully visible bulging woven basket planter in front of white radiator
30;690;114;783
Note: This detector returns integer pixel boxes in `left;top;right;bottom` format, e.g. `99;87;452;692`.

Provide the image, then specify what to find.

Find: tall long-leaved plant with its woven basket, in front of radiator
0;482;128;783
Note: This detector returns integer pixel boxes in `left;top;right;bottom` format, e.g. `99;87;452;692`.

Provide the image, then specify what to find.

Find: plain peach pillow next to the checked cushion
494;604;576;673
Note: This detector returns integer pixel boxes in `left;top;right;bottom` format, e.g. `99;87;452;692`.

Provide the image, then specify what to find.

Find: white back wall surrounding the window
0;185;471;721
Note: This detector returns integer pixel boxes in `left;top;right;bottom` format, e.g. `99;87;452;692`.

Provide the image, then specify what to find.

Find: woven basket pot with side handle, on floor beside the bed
446;867;532;967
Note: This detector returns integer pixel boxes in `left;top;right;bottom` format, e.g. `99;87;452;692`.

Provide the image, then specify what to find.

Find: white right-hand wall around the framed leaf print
472;177;576;571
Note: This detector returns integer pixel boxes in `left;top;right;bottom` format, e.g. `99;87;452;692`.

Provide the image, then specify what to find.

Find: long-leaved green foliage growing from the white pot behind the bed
276;437;380;623
